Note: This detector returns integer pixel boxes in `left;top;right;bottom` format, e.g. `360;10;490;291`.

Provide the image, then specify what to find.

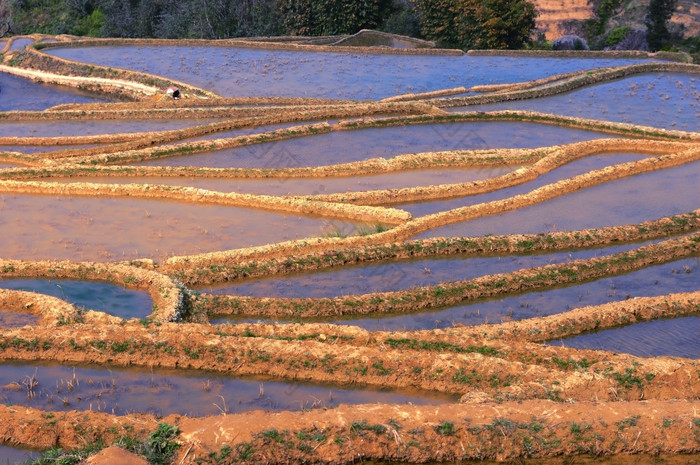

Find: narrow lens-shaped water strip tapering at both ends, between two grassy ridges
197;239;648;298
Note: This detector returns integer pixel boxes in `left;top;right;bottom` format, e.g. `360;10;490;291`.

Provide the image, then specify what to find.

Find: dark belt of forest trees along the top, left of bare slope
0;0;536;48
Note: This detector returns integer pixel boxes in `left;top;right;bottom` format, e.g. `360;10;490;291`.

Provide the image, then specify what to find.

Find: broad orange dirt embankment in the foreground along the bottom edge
0;401;700;464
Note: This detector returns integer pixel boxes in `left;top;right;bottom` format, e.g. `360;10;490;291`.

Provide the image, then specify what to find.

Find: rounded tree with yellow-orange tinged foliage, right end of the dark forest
416;0;537;50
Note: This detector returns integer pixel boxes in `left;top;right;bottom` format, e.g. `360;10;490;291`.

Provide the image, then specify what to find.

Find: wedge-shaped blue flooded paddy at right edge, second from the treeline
449;73;700;131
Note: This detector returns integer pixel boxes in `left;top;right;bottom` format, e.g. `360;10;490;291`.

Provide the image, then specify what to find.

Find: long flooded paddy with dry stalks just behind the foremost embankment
0;363;457;416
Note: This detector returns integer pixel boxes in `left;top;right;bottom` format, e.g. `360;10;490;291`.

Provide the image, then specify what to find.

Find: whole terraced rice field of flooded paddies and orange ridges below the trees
0;36;700;464
